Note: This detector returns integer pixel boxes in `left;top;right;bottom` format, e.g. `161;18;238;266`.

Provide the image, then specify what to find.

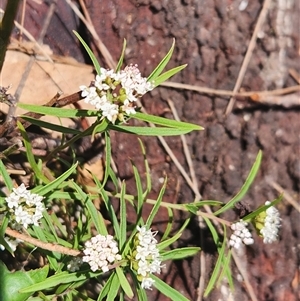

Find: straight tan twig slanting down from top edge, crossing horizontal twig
225;0;272;116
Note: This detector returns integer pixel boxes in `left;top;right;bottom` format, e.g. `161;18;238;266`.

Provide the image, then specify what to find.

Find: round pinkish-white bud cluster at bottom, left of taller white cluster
82;234;122;273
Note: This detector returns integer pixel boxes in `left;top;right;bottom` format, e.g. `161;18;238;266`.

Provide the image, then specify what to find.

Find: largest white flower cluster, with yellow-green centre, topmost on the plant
79;65;154;123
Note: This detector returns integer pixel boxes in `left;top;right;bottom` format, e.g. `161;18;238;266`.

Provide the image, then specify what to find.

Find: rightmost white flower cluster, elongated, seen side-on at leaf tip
260;201;281;244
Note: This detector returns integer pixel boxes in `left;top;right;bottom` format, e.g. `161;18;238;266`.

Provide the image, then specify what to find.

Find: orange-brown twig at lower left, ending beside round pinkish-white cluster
5;227;81;256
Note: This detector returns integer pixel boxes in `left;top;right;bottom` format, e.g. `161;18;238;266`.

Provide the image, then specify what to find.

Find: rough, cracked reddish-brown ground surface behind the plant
1;0;300;301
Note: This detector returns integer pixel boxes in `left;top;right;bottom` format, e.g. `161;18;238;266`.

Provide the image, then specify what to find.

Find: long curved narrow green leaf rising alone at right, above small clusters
214;151;262;215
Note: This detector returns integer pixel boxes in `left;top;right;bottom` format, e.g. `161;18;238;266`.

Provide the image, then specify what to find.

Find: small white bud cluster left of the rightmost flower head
229;220;254;249
